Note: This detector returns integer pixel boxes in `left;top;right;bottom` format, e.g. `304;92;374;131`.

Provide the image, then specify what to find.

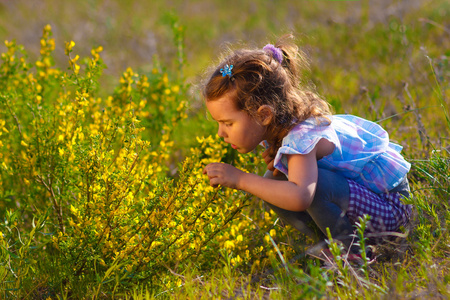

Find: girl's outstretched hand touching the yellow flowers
203;163;246;189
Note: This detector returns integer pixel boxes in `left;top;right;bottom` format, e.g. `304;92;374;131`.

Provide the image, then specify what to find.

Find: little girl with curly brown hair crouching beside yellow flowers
203;35;411;256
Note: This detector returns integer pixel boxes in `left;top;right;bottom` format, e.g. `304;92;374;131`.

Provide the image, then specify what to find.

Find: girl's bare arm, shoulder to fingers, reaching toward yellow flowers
204;140;331;211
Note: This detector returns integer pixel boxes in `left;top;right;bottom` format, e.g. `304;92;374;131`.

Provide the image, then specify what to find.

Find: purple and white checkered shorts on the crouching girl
347;180;412;233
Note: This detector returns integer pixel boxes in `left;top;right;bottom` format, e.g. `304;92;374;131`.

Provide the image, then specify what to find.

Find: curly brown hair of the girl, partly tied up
203;34;331;156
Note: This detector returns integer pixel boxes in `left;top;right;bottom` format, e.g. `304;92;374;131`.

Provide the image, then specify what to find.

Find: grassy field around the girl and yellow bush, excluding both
0;0;450;299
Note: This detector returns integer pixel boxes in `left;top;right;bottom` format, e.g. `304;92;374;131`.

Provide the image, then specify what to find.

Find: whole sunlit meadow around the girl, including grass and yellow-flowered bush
0;0;450;299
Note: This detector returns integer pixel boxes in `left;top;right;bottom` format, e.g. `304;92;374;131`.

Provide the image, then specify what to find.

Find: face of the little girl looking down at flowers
206;94;267;153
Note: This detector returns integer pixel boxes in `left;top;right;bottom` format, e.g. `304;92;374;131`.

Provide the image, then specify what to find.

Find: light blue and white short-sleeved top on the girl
274;115;411;193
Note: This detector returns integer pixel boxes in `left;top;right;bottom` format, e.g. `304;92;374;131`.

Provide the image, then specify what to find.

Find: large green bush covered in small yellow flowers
0;26;302;295
